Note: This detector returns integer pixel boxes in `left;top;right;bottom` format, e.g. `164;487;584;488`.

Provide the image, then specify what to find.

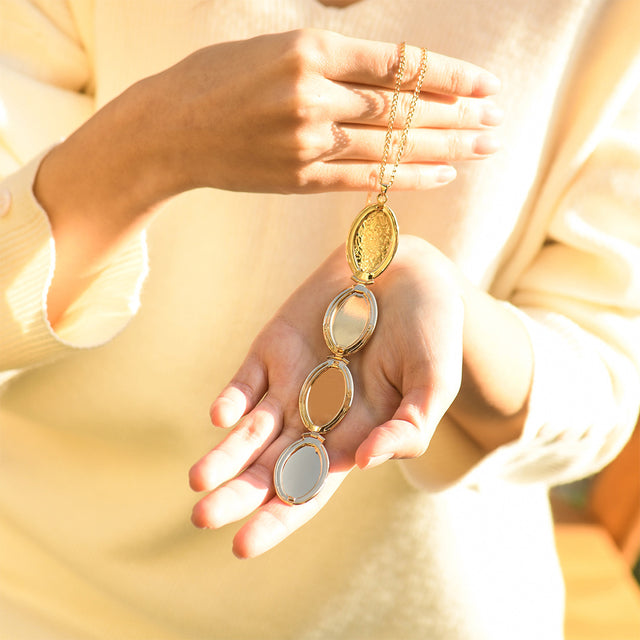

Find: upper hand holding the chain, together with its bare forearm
34;30;501;328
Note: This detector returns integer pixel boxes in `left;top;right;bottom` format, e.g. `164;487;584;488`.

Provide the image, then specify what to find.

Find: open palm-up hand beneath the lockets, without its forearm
190;236;464;557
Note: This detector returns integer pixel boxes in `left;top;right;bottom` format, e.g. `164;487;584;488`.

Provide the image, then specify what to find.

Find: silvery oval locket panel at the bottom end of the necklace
273;433;329;504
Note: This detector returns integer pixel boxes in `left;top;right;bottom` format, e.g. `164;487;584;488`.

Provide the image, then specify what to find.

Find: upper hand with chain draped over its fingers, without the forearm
147;30;501;193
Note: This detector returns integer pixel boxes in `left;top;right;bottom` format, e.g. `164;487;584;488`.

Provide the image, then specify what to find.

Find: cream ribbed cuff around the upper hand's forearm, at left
0;153;148;370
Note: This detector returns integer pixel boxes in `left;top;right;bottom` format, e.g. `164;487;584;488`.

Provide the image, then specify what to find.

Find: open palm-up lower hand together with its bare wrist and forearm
190;236;532;558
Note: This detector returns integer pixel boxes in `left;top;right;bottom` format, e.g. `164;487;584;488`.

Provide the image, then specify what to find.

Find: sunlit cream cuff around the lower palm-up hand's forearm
463;305;634;486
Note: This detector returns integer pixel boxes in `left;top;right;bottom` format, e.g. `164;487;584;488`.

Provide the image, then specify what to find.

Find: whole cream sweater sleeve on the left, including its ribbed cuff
0;0;147;372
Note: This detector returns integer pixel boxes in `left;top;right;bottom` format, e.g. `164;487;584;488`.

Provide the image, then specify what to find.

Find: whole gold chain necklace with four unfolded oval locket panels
274;42;428;504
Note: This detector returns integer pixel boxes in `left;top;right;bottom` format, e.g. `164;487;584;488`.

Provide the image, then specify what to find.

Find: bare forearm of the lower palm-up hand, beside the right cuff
449;282;533;451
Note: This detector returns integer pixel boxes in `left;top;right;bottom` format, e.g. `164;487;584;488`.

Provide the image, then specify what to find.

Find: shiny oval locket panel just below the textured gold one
322;284;378;356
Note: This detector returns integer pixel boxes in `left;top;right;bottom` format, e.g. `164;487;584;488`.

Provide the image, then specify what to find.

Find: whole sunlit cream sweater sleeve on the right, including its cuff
468;82;640;484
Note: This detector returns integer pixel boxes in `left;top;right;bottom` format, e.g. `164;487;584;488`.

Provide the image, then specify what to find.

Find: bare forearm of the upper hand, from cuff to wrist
34;77;170;327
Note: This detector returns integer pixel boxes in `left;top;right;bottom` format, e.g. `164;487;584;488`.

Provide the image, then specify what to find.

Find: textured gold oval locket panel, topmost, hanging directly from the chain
347;204;398;284
